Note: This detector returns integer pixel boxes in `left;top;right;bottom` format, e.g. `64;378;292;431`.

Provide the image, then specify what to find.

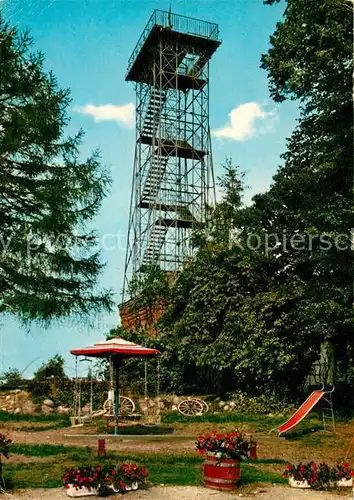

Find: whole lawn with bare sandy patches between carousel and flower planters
0;413;353;488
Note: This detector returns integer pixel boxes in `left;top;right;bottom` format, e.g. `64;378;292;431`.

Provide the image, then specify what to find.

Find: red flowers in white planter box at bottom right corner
283;462;354;490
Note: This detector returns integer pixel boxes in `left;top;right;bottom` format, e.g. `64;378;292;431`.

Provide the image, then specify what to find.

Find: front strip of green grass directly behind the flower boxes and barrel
4;444;284;488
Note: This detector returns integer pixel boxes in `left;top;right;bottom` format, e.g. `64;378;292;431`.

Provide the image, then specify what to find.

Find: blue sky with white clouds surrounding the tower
0;0;298;376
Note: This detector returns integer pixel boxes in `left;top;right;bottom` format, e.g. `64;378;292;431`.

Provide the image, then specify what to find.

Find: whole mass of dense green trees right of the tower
115;0;354;398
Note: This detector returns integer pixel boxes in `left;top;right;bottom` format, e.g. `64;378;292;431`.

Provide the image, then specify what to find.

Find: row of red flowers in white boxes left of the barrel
62;462;148;497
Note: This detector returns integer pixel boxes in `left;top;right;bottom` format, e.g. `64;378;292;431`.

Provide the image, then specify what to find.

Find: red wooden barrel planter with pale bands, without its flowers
204;453;241;490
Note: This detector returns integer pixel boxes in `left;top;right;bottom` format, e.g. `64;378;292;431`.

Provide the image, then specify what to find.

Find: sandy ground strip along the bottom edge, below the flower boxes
2;486;352;500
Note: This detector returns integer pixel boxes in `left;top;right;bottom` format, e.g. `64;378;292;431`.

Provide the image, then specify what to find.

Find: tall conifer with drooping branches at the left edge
0;17;112;321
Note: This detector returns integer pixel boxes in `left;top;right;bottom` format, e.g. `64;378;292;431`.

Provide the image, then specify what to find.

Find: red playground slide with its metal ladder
270;387;335;436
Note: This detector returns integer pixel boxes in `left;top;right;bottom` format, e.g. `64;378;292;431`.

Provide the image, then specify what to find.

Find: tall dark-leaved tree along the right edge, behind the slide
238;0;354;386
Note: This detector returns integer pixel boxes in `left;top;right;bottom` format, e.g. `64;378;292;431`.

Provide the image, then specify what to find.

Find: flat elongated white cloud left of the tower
74;102;135;128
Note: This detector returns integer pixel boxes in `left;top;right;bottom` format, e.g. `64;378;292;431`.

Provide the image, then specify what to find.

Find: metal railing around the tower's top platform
127;9;219;74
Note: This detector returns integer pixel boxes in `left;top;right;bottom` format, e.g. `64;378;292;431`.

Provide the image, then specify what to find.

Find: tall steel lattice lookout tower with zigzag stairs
123;10;221;301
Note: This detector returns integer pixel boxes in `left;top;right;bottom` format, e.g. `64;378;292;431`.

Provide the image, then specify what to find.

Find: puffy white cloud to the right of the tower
212;102;275;141
